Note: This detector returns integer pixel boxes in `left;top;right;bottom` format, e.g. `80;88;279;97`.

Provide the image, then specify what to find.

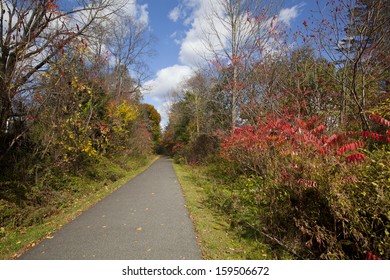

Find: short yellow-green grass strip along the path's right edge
174;164;274;260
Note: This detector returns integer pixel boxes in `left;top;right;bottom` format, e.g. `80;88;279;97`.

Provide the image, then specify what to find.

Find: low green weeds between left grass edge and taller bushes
0;156;152;231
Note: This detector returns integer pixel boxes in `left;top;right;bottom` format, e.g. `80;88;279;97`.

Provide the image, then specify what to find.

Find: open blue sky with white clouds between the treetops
136;0;315;128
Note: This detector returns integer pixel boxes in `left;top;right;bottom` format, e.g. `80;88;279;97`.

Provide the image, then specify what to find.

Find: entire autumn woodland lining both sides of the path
0;0;390;259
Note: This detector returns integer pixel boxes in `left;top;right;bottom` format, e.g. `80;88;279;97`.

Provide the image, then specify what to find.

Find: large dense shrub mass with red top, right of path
206;116;390;259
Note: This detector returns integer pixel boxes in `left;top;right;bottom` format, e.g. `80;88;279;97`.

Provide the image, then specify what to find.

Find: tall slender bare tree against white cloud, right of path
204;0;277;128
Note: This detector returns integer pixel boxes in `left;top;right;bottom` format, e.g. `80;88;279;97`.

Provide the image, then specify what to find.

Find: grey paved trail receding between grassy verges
20;158;201;260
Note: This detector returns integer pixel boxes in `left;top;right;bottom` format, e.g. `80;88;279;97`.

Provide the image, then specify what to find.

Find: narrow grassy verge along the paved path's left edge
0;156;157;259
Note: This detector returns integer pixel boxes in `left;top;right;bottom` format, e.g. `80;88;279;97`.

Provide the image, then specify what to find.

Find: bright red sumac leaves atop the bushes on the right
221;112;372;173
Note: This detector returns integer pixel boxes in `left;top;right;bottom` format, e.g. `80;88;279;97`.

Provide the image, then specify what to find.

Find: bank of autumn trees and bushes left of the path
0;0;160;235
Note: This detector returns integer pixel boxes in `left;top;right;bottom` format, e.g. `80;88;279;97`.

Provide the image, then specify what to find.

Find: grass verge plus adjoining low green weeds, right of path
174;164;295;260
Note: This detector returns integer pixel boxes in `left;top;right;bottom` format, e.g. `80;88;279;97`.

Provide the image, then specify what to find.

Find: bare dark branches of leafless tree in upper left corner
0;0;124;135
